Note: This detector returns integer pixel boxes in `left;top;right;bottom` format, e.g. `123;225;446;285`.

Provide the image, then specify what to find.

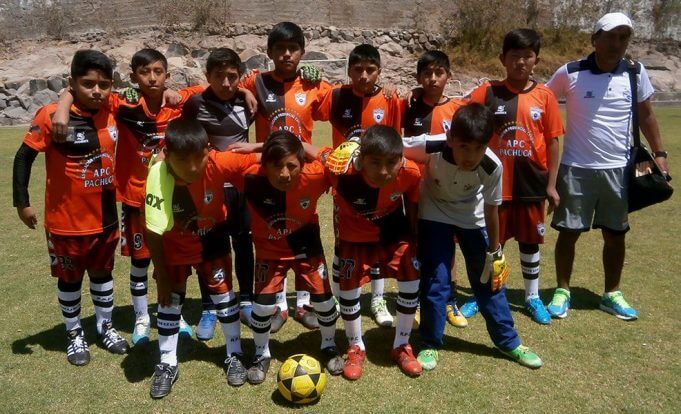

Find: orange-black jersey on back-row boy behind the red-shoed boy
319;85;401;148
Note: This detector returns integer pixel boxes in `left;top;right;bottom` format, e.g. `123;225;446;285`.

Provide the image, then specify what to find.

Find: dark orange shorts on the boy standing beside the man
499;201;546;244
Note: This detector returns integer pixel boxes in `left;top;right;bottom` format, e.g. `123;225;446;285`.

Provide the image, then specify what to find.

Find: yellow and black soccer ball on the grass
277;354;326;404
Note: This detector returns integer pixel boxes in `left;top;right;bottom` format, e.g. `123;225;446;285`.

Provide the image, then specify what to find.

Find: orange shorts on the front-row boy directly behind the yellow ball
253;256;331;305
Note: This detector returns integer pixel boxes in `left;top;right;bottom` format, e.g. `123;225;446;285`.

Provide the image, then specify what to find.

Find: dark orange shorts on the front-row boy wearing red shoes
333;240;419;290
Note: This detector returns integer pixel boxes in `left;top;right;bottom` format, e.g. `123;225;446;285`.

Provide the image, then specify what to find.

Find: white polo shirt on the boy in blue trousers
403;134;502;229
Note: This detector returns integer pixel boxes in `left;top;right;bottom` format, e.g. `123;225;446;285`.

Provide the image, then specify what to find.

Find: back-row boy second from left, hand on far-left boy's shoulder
54;49;205;345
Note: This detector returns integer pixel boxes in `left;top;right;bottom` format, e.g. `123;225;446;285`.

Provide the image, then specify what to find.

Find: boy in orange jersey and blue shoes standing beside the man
461;29;563;325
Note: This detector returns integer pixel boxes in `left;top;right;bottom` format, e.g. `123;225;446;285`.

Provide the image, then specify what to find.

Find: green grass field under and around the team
0;108;681;413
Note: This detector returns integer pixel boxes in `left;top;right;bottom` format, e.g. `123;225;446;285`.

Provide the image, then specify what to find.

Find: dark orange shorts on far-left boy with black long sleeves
45;226;119;283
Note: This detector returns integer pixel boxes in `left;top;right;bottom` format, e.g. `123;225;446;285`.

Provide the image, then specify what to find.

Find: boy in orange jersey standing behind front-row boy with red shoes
319;44;401;327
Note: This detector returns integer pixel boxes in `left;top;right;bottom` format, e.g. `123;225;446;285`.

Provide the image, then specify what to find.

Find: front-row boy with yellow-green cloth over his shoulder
145;118;257;398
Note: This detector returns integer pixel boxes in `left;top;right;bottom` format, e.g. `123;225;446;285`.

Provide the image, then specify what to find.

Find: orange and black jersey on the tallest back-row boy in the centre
242;72;331;143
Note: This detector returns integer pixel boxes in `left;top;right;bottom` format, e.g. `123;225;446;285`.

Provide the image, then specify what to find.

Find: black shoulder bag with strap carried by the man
626;60;674;213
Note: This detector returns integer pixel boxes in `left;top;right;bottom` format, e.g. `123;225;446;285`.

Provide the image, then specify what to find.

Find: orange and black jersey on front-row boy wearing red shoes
322;153;421;244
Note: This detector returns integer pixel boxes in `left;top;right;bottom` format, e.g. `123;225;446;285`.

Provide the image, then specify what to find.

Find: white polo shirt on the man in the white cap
546;53;655;169
